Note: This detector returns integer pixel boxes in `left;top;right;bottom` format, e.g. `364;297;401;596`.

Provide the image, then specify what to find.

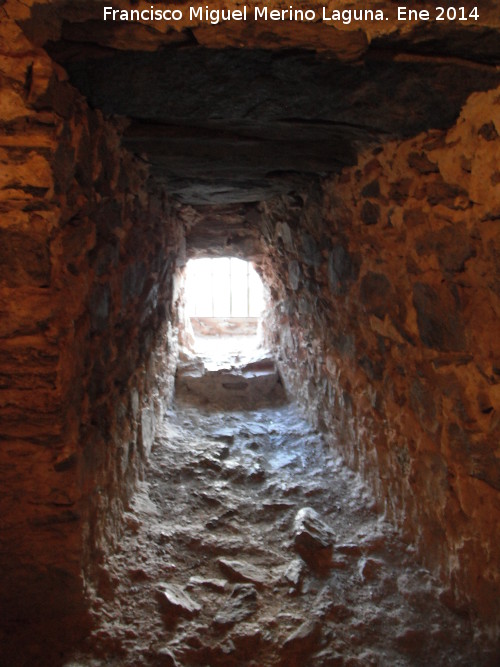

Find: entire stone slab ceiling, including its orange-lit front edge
21;0;500;204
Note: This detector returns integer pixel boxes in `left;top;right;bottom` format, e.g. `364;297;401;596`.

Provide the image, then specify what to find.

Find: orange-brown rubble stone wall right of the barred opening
262;90;500;626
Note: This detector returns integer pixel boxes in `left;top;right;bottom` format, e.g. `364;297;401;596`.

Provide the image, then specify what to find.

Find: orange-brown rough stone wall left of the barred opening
0;11;182;657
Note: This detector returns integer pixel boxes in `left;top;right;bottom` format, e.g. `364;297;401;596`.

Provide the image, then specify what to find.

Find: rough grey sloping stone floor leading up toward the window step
66;403;493;667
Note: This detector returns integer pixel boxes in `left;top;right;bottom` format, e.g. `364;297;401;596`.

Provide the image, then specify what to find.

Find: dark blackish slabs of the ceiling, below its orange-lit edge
46;17;500;204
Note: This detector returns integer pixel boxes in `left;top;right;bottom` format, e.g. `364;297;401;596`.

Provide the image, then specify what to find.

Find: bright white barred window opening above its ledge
186;257;264;318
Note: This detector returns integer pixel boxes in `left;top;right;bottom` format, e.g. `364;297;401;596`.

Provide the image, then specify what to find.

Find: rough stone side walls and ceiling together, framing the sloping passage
0;0;500;664
